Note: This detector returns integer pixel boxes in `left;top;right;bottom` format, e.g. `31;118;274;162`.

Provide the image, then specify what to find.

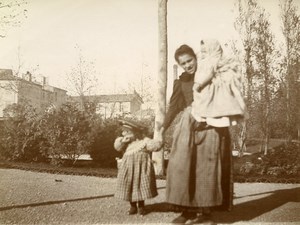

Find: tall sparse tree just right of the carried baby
235;0;279;154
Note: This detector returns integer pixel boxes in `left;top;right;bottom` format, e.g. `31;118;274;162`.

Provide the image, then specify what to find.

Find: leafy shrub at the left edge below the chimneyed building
0;103;45;161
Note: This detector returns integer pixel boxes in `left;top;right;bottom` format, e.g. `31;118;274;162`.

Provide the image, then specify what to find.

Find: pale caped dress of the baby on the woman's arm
191;55;246;127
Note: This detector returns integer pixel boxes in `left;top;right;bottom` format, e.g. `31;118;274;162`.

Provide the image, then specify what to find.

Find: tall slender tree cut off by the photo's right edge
280;0;300;143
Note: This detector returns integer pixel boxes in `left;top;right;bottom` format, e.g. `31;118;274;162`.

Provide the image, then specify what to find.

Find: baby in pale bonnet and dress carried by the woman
191;39;246;127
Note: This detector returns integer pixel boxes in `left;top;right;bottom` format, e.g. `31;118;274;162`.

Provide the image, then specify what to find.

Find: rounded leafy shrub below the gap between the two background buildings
40;103;97;164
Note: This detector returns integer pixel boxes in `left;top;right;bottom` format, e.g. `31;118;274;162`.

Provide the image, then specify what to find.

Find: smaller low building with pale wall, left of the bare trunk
68;91;143;118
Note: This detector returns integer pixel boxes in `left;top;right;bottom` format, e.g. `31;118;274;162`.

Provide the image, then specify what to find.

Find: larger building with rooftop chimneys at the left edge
0;69;67;117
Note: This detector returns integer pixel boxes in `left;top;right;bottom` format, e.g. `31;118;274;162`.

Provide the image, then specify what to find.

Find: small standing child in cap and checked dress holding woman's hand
114;120;162;215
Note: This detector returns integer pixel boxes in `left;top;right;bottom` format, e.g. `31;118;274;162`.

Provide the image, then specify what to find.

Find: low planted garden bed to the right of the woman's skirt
233;142;300;183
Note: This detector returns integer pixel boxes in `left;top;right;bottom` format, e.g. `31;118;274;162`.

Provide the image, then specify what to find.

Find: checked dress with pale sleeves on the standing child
114;137;158;202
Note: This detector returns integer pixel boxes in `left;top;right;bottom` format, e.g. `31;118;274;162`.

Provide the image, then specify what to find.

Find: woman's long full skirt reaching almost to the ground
166;109;233;210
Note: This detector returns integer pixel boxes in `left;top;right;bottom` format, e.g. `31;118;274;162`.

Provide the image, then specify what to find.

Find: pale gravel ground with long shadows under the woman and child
0;169;300;224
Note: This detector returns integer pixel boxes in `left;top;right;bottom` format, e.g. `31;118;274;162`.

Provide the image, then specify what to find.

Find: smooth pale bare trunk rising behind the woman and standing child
152;0;168;175
